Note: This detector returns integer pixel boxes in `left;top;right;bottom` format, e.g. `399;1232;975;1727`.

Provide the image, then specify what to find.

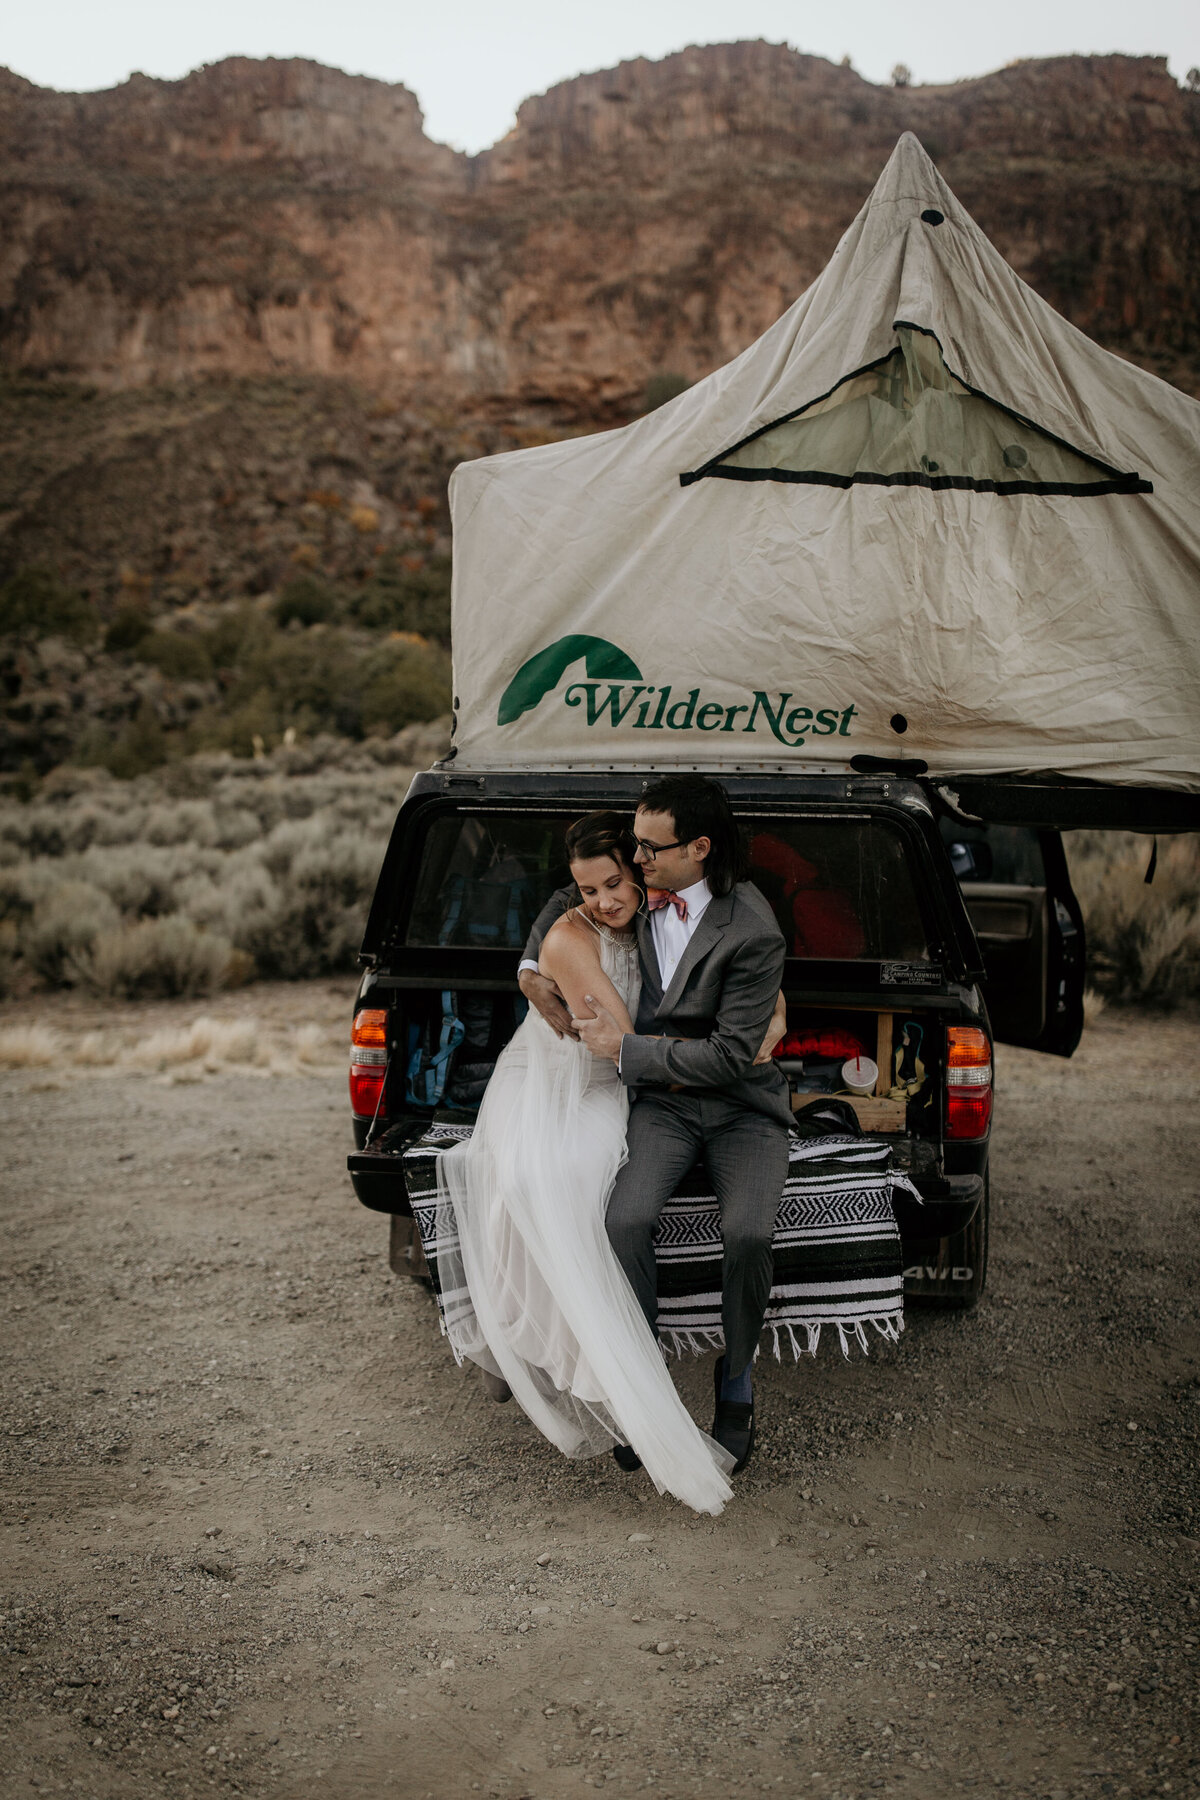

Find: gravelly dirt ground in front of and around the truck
0;985;1200;1800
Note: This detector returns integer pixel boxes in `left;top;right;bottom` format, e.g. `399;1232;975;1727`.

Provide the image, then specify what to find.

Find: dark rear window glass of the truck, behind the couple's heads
407;810;928;961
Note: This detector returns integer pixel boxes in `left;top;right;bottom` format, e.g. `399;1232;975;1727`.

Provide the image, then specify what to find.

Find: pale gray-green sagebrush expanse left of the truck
0;725;446;999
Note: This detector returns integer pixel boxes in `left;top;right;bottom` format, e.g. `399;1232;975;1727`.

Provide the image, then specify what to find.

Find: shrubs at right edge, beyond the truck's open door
1067;832;1200;1008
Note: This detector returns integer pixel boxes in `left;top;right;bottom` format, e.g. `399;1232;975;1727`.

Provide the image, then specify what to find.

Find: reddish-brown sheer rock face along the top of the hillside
0;43;1200;423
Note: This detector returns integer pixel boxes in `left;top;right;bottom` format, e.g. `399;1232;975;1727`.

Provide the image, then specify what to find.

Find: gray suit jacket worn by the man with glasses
524;882;792;1125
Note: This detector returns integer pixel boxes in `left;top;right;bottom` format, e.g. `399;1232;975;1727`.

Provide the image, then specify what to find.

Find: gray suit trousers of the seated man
606;1089;788;1375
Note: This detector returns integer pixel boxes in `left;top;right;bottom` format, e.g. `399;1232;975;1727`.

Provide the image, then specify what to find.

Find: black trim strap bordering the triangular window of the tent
680;319;1155;497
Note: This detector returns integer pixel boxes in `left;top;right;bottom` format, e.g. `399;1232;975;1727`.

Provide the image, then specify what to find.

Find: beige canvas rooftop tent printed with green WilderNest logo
450;135;1200;794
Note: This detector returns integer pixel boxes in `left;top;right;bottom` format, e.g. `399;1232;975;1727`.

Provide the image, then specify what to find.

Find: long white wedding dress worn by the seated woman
437;925;732;1512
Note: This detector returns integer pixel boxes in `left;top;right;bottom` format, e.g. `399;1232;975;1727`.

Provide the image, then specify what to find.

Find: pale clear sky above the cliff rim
9;0;1200;151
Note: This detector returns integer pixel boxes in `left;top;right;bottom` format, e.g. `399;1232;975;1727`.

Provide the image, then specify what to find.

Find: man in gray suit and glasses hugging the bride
520;774;792;1472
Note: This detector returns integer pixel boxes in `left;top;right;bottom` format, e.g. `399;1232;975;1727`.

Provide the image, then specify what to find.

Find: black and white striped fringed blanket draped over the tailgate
405;1125;916;1357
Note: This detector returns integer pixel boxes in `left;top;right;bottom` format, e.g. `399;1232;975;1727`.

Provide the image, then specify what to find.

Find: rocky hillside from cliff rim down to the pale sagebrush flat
0;43;1200;774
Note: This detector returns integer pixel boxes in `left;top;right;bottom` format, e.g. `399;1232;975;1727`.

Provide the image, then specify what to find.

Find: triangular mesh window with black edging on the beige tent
680;326;1151;495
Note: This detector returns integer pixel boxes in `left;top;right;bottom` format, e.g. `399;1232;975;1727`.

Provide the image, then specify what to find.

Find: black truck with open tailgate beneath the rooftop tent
349;767;1083;1307
